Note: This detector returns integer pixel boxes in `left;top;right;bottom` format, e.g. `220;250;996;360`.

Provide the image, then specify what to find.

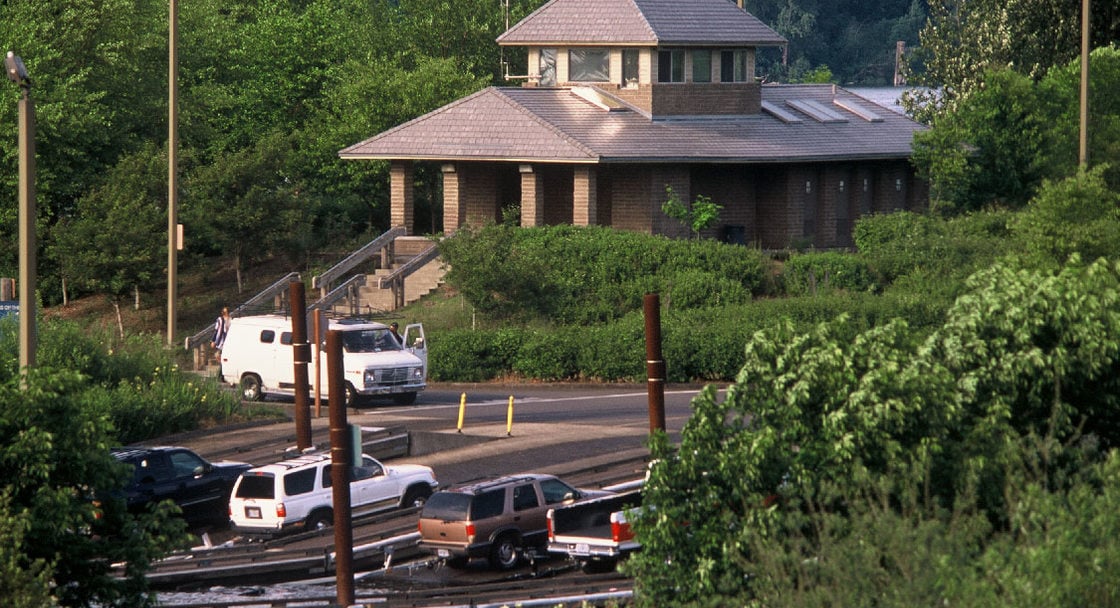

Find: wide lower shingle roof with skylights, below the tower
339;83;925;163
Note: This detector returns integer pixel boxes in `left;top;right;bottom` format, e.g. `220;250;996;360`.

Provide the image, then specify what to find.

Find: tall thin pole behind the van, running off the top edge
167;0;179;346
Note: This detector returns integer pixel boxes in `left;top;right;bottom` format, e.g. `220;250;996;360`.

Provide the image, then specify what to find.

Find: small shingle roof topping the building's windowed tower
497;0;786;47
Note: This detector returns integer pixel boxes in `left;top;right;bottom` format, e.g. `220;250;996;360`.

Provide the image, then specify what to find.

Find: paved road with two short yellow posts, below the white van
161;384;716;485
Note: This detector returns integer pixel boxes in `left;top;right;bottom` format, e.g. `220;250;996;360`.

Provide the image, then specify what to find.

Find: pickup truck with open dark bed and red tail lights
548;489;642;572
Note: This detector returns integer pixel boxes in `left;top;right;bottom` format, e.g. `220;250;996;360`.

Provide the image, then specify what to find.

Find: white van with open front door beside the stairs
222;315;428;405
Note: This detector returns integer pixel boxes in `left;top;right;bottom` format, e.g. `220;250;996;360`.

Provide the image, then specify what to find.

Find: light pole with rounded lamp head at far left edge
3;50;37;374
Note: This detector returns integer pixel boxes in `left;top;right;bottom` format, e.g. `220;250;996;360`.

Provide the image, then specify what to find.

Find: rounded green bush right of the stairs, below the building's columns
440;225;768;324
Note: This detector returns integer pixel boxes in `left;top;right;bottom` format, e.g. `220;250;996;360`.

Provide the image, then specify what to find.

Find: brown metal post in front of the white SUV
327;329;354;606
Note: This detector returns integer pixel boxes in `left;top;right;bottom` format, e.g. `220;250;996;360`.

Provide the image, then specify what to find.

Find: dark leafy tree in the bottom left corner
0;367;187;606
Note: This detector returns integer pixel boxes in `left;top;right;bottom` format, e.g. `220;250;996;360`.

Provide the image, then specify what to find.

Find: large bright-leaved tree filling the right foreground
628;260;1120;606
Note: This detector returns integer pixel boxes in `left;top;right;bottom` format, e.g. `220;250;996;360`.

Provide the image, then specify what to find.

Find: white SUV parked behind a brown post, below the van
230;453;438;536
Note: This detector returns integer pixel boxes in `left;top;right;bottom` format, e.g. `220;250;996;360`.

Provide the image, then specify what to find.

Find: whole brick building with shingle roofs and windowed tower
339;0;928;249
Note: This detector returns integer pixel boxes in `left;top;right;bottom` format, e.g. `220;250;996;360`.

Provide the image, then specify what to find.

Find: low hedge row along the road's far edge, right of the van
430;293;950;382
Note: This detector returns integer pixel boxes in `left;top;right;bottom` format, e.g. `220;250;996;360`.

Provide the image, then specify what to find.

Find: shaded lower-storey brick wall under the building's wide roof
444;160;928;249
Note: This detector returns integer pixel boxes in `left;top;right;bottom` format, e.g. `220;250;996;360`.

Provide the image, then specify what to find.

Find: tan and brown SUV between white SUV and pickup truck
419;474;610;570
